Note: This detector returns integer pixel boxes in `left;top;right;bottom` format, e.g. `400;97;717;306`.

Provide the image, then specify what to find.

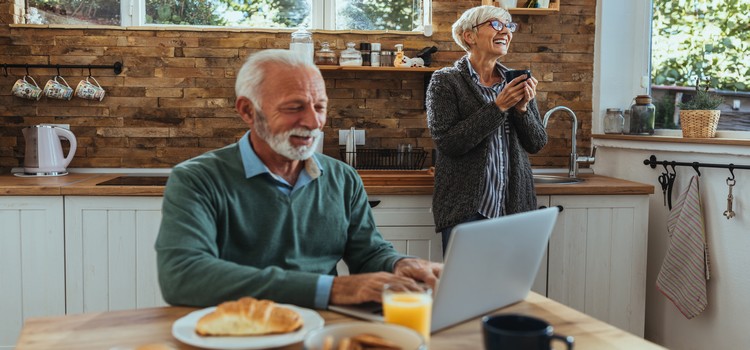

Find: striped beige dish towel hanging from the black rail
656;176;710;319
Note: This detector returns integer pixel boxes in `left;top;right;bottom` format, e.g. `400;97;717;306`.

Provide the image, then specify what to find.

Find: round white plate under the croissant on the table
172;304;325;350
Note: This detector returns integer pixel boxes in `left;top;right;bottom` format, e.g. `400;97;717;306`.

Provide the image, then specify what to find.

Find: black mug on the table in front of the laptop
482;314;573;350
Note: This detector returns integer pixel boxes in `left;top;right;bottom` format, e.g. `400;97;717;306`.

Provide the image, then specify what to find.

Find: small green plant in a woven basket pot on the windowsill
678;79;724;138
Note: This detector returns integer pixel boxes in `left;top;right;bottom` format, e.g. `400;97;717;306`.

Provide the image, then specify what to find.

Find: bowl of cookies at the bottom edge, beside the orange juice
304;322;427;350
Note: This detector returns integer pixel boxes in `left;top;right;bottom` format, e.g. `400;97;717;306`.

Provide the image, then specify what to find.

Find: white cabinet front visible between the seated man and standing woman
369;195;443;262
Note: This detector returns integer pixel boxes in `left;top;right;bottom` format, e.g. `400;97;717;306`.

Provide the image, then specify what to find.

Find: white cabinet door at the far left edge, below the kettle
0;196;65;348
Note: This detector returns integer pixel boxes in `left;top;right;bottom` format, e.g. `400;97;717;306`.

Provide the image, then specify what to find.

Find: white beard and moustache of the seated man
255;109;323;160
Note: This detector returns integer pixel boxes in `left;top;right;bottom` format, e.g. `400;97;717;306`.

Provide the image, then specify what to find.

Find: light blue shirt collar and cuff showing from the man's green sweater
239;131;333;309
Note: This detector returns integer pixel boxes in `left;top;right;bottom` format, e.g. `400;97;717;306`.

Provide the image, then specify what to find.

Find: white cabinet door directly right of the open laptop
547;195;648;336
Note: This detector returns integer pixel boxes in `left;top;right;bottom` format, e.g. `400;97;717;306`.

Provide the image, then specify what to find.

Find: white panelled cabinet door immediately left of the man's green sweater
65;196;166;313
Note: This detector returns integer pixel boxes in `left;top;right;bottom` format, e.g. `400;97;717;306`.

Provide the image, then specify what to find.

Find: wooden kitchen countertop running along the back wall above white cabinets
0;170;654;196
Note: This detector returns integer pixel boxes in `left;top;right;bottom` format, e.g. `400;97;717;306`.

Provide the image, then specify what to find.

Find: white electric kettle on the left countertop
23;125;78;175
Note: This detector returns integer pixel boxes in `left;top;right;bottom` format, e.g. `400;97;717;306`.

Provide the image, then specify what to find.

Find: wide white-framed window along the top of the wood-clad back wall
26;0;432;35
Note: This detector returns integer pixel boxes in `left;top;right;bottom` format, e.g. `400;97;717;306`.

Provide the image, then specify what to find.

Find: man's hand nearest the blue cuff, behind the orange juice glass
329;272;422;305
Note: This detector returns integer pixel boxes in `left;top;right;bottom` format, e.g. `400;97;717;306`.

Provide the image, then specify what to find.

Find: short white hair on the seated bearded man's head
234;49;320;109
